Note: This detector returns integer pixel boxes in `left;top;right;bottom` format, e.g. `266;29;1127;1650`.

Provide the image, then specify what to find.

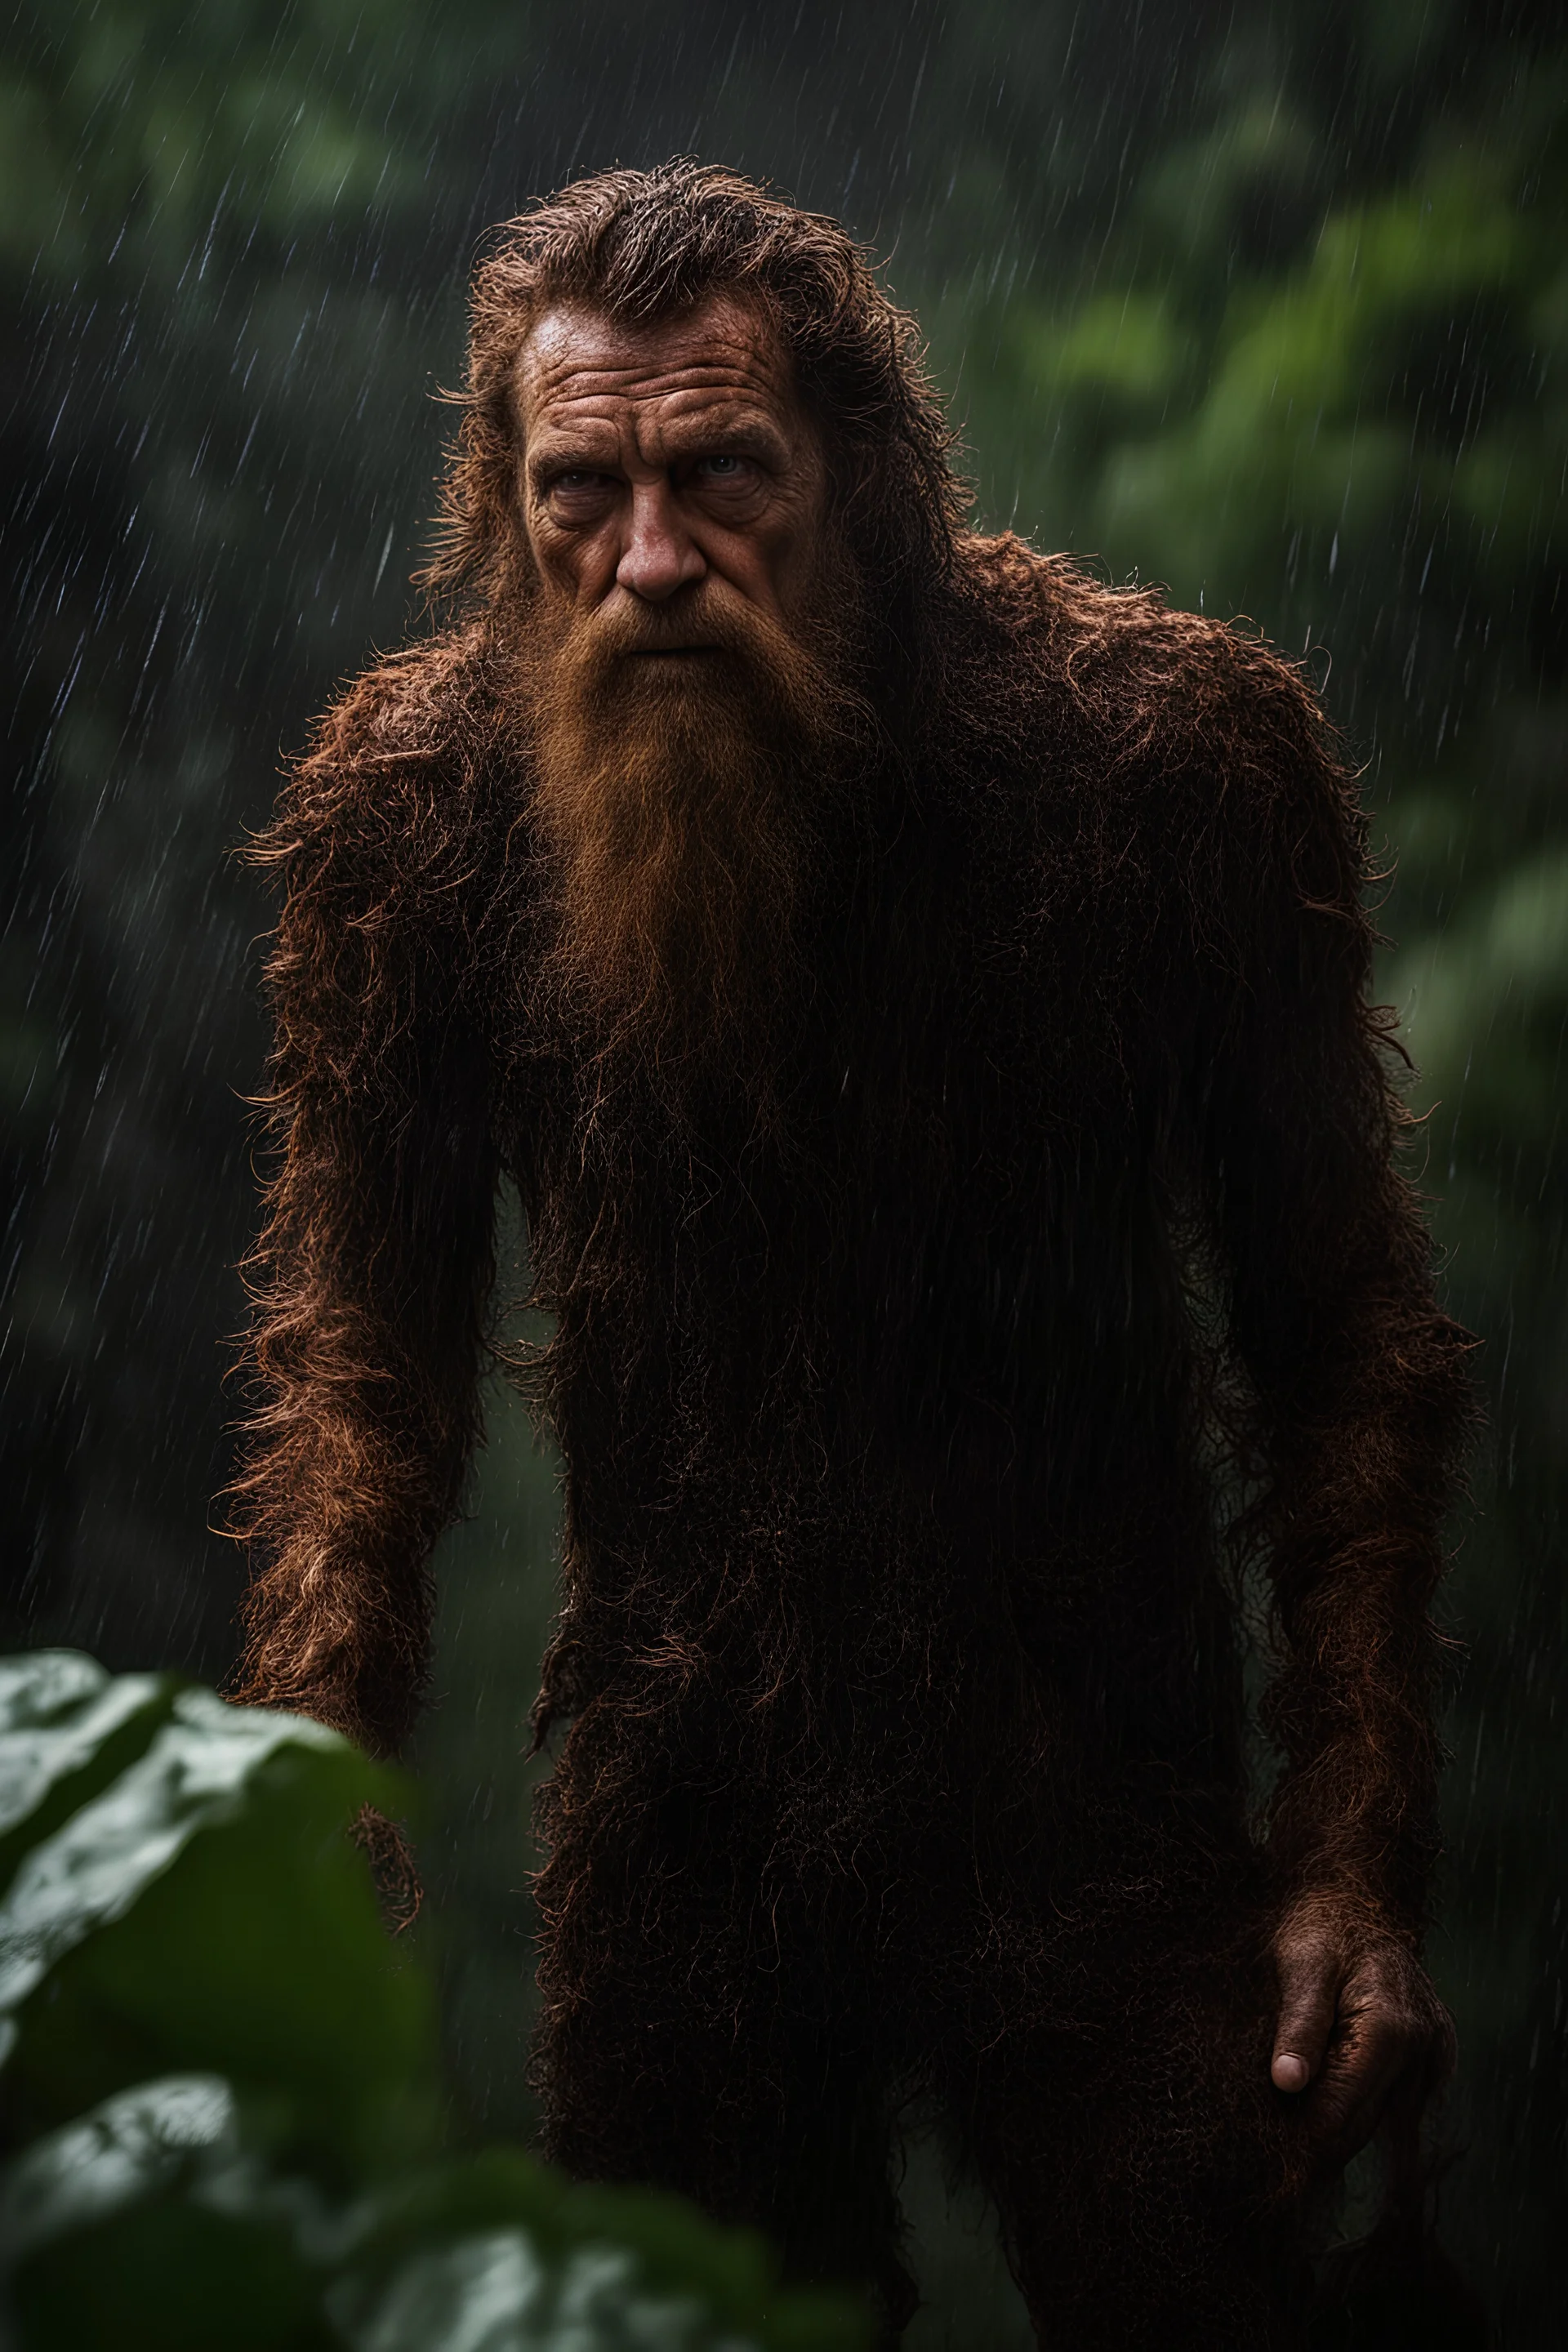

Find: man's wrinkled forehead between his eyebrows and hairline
513;294;802;438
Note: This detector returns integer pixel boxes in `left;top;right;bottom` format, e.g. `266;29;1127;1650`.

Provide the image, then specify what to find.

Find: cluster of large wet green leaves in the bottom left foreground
0;1651;861;2352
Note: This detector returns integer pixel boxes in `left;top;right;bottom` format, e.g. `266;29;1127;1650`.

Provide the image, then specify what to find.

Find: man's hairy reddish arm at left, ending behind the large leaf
235;653;493;1754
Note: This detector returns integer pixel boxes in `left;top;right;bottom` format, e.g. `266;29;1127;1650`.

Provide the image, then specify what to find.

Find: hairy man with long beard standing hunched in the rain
230;165;1467;2352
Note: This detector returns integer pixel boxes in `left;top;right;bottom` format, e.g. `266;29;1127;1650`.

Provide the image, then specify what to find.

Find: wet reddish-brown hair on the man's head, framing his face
423;160;969;598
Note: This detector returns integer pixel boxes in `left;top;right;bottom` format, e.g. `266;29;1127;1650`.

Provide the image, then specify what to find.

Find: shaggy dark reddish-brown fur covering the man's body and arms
230;161;1469;2345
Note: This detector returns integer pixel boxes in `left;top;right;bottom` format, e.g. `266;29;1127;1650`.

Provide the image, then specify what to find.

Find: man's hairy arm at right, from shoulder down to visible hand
1190;647;1472;2159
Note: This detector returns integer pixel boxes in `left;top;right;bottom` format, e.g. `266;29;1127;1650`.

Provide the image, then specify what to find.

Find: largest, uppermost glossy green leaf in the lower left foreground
0;1651;437;2173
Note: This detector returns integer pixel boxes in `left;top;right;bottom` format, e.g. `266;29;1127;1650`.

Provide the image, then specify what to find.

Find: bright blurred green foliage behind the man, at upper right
947;61;1568;642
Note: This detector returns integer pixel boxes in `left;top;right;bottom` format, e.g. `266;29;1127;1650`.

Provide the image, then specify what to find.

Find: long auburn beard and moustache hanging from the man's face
517;559;877;1080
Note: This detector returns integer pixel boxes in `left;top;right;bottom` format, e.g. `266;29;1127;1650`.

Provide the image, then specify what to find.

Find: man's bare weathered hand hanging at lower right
1272;1895;1453;2171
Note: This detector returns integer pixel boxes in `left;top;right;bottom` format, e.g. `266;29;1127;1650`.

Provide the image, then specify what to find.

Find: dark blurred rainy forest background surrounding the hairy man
0;0;1568;2347
